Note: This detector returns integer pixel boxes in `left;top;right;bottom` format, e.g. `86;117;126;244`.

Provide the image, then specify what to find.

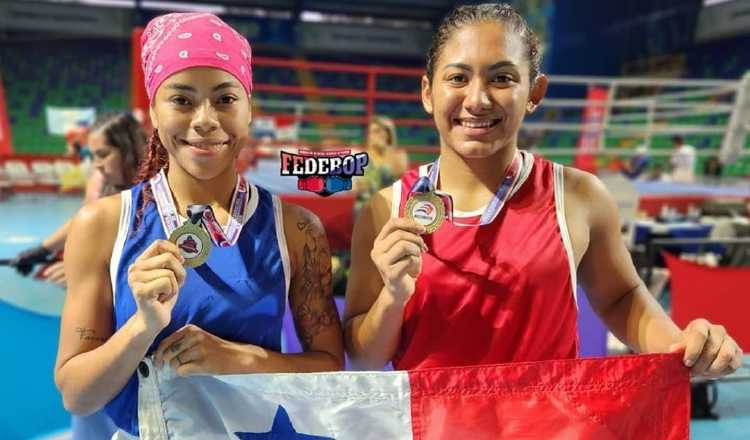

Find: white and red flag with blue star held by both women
139;354;690;440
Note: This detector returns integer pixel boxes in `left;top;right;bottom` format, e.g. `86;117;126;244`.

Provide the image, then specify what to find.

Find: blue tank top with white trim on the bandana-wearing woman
105;182;290;435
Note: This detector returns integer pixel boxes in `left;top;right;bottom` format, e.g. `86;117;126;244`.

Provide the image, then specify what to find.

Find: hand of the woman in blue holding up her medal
128;240;185;332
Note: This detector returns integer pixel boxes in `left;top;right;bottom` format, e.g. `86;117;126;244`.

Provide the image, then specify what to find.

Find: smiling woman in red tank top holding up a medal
344;4;741;377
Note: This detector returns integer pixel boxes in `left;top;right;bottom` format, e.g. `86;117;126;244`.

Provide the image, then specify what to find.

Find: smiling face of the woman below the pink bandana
150;67;252;180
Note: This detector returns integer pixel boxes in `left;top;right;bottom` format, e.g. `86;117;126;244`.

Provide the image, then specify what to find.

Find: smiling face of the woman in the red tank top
422;21;547;158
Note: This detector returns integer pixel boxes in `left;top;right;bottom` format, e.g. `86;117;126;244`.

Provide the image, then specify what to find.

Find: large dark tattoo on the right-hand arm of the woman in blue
289;213;340;351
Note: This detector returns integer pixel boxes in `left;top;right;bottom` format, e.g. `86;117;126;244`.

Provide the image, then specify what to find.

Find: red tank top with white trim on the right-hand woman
392;153;578;370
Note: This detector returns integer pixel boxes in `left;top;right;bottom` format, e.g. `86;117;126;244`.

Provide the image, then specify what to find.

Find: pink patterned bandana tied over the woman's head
141;12;253;100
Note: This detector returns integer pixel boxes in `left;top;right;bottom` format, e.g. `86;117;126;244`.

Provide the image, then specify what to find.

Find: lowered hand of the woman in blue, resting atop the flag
154;324;250;376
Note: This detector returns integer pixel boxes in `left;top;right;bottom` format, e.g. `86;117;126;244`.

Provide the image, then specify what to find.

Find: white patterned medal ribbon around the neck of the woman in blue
150;170;249;247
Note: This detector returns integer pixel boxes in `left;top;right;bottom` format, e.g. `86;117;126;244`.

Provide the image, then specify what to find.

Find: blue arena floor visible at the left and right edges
0;195;750;440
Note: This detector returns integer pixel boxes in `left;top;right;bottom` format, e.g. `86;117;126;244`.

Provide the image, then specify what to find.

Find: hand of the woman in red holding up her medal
370;218;427;304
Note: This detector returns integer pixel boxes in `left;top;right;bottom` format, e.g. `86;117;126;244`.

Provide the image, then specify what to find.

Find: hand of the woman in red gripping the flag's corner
669;319;742;379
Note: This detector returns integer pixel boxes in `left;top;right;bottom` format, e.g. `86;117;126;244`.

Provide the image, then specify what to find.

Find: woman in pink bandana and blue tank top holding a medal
55;13;343;435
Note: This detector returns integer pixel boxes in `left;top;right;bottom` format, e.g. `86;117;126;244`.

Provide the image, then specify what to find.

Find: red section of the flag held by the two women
409;354;690;440
